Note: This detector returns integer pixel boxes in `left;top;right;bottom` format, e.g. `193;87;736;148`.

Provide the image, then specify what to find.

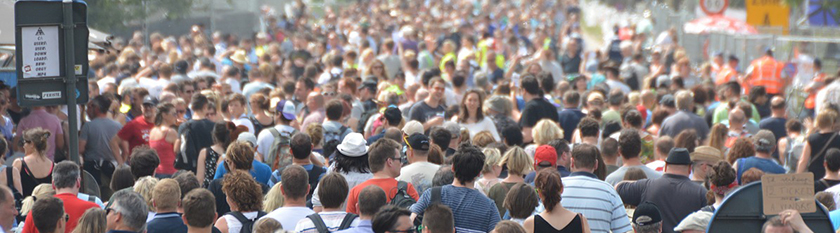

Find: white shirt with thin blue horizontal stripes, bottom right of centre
560;172;633;233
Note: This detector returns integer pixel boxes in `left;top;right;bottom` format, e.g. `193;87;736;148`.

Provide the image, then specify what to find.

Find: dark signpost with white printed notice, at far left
15;0;88;163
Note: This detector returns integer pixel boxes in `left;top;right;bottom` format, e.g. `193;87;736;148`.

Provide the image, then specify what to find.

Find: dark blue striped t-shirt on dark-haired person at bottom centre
409;184;501;232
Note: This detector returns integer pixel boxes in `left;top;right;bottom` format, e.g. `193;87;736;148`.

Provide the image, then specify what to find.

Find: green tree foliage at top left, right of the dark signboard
87;0;196;31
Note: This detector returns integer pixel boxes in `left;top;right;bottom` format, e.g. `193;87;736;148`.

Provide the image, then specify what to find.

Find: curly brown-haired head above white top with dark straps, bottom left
222;171;262;212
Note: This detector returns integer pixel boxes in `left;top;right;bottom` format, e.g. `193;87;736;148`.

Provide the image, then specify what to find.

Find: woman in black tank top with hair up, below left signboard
12;127;55;197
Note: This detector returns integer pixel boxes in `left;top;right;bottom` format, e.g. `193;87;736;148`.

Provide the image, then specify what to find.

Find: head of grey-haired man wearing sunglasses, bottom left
105;190;148;232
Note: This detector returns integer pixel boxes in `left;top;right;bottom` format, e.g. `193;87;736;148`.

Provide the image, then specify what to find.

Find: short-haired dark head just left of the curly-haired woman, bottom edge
181;189;218;228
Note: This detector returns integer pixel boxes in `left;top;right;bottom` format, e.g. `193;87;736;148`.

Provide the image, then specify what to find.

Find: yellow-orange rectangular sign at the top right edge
746;0;790;34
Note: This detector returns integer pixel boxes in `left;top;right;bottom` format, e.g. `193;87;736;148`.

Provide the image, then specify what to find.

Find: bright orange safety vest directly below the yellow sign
744;56;784;95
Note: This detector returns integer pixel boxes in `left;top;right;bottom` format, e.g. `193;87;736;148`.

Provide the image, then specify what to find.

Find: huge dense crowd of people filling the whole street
0;0;840;233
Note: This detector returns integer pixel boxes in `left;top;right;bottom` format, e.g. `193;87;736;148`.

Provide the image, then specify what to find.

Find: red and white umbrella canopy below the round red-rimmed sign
683;15;758;34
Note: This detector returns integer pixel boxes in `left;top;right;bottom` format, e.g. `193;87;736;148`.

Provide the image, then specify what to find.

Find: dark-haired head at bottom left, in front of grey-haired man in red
29;197;70;233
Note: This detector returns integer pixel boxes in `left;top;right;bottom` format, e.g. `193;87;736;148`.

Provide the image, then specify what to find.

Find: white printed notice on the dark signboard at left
21;26;61;78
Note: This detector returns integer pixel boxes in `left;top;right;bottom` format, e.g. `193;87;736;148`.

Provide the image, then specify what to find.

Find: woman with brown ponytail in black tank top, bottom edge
524;169;590;233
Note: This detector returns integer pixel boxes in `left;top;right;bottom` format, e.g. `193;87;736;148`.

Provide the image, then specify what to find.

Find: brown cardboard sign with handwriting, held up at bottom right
761;172;817;215
